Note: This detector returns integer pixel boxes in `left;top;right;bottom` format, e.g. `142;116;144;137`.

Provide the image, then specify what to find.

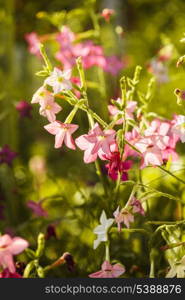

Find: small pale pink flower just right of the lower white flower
113;206;134;231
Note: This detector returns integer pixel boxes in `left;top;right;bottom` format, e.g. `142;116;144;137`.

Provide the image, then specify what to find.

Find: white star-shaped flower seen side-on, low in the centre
93;210;114;249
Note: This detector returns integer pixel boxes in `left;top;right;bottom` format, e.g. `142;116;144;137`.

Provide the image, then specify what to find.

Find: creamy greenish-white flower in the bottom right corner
166;255;185;278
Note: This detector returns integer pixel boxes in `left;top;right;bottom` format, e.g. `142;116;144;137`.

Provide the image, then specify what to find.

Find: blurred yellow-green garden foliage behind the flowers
0;0;185;277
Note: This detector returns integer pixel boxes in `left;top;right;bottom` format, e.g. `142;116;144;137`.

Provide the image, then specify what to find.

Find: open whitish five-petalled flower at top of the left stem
44;68;72;94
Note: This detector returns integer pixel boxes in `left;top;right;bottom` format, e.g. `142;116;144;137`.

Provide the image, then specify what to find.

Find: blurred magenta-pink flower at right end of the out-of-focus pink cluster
103;55;124;76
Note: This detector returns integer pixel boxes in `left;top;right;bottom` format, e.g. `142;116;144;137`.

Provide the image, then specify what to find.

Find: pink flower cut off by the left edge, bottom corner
0;234;28;273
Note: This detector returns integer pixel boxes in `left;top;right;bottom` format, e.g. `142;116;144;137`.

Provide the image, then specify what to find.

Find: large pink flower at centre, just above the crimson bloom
75;123;117;163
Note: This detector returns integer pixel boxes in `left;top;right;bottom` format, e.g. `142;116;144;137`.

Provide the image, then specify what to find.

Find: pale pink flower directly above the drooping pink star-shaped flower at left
39;99;62;122
